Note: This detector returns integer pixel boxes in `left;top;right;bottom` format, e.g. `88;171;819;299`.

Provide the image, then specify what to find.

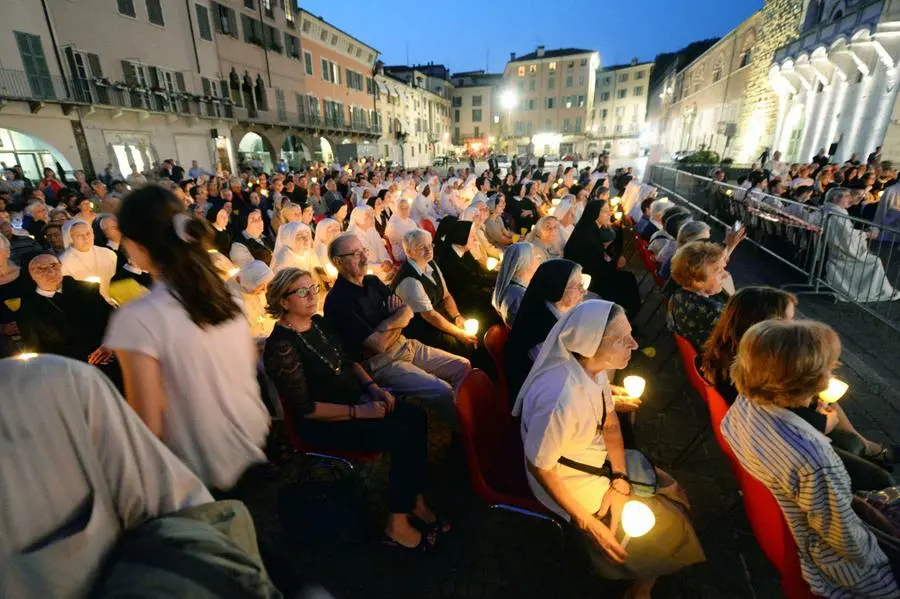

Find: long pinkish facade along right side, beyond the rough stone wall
654;12;761;158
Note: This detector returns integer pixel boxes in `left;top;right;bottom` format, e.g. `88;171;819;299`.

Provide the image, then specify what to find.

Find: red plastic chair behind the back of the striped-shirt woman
735;462;817;599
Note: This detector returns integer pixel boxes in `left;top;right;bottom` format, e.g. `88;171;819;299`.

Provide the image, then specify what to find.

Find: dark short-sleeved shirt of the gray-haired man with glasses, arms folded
325;275;393;360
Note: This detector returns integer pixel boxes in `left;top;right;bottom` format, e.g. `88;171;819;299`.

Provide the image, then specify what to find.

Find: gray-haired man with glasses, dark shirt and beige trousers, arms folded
325;233;471;426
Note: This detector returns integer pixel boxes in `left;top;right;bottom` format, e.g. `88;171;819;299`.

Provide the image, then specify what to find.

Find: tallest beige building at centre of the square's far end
503;46;600;156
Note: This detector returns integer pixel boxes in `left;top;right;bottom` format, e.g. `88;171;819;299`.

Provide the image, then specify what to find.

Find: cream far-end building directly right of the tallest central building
588;58;653;157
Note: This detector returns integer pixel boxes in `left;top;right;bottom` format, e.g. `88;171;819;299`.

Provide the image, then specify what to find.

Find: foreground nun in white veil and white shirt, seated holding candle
513;300;705;597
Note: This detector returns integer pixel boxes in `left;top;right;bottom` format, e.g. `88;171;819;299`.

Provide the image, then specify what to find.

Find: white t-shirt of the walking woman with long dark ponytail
103;282;270;490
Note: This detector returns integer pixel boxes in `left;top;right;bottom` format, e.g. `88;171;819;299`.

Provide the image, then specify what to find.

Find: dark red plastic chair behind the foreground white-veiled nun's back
456;368;559;527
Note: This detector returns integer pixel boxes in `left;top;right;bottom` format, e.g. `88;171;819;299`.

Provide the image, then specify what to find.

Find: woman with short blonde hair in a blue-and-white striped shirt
721;320;900;598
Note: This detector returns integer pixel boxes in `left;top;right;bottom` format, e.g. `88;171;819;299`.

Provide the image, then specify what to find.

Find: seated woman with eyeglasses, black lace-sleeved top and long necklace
263;268;448;551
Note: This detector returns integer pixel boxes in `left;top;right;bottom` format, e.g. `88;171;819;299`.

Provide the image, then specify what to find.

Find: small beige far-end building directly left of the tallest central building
451;71;506;152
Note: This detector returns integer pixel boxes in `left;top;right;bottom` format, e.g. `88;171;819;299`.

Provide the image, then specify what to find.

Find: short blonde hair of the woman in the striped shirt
731;320;841;408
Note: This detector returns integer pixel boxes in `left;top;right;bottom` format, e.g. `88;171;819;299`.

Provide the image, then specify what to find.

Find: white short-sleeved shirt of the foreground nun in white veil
522;365;615;520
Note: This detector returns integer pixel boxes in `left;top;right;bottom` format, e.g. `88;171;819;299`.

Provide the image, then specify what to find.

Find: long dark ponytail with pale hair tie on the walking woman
119;185;241;328
